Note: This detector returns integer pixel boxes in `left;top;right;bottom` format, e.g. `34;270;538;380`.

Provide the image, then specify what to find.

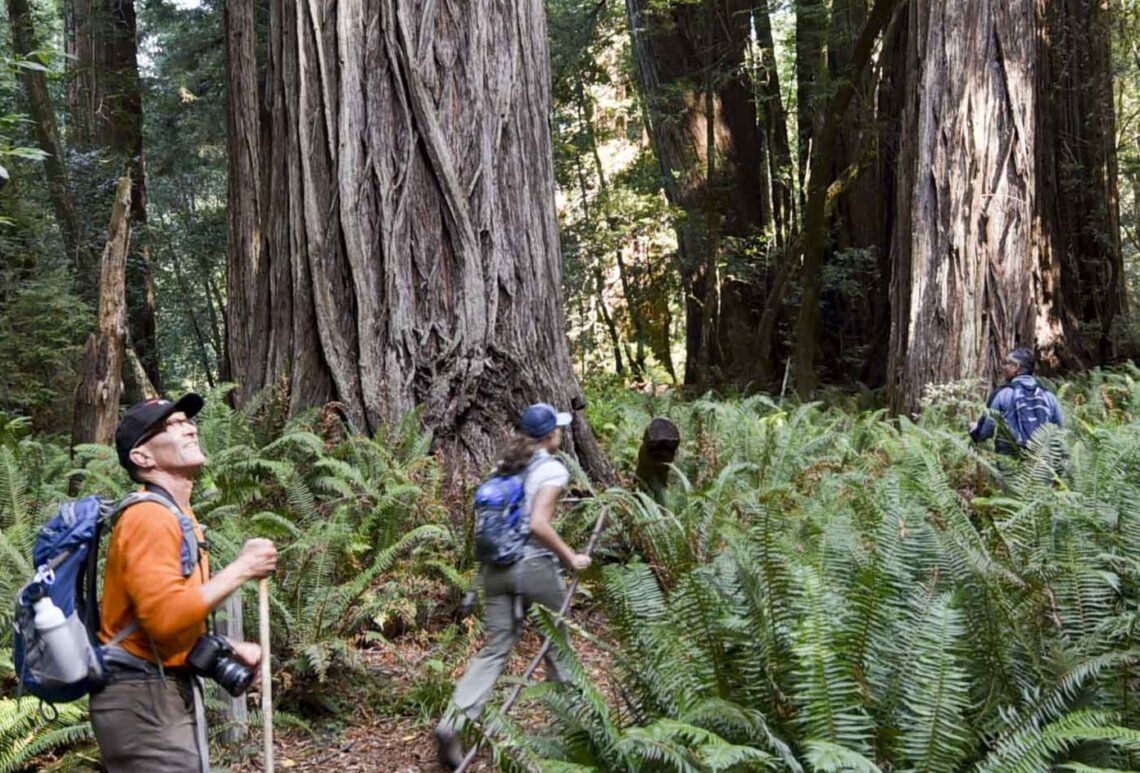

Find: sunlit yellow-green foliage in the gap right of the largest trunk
546;0;681;382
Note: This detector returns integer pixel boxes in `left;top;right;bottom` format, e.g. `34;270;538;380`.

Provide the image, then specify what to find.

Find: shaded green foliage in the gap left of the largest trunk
139;1;227;385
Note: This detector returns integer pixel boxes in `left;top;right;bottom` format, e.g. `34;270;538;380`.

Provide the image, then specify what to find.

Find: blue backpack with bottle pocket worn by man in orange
13;491;200;703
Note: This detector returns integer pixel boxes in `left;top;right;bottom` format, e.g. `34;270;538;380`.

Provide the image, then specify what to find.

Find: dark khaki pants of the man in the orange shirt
91;676;210;773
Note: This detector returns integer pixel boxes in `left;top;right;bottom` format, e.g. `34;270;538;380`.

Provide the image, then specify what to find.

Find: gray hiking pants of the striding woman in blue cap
441;555;565;730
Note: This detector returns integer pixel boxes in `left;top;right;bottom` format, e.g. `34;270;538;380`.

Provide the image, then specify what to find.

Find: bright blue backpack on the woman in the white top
475;459;535;567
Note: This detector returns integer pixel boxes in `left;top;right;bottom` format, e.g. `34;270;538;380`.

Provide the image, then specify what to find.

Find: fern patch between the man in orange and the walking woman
185;388;451;691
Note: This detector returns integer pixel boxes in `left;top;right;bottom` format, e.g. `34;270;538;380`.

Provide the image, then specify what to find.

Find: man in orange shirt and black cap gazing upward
90;393;277;773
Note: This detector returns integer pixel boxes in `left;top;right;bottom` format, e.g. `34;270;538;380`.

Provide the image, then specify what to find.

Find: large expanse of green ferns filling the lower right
498;385;1140;772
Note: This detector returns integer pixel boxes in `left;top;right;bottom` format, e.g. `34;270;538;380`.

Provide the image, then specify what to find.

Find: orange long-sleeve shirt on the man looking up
99;502;210;667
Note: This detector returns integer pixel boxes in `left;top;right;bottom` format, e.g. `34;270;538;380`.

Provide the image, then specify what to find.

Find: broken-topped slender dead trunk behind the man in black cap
72;177;131;445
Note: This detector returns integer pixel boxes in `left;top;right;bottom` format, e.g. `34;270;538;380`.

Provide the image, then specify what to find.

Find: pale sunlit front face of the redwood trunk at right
897;0;1036;407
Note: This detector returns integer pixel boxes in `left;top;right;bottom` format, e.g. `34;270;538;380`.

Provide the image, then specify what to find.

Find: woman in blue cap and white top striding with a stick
432;402;591;770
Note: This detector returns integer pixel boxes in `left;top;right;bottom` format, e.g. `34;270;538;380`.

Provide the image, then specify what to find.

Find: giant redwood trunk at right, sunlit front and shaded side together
888;0;1121;410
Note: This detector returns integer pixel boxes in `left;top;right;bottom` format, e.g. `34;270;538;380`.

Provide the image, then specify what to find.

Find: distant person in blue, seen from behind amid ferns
970;348;1064;456
